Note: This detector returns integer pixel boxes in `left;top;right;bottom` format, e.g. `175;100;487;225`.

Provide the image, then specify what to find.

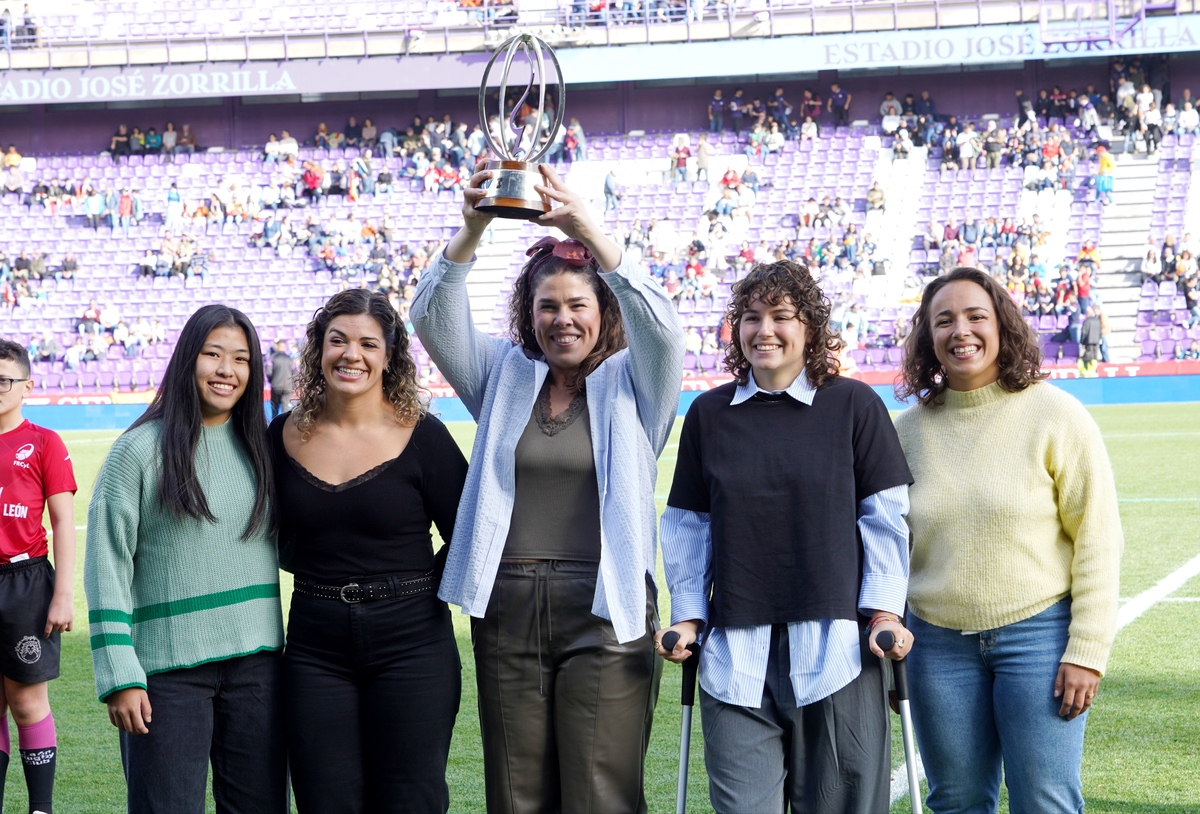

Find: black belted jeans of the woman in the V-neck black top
283;580;462;814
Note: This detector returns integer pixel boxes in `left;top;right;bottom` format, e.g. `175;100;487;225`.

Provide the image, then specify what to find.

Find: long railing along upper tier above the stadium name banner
0;0;1196;71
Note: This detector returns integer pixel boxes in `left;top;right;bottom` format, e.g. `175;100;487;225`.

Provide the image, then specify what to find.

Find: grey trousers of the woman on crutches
700;624;892;814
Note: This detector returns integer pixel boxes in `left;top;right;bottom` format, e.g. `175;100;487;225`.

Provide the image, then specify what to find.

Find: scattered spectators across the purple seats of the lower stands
9;56;1200;386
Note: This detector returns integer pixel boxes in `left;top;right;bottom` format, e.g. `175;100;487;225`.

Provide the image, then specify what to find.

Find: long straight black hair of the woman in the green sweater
126;305;275;540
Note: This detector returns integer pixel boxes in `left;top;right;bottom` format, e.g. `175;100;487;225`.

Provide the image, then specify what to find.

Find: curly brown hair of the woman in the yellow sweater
895;265;1046;407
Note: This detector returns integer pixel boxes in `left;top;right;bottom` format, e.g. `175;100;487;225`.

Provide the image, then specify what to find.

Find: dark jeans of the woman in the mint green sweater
121;652;288;814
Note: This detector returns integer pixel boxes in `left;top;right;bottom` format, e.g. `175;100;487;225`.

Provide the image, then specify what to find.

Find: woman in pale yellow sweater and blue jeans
896;268;1123;814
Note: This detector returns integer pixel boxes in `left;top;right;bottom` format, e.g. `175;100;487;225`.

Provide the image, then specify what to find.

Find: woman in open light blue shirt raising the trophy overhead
410;164;684;814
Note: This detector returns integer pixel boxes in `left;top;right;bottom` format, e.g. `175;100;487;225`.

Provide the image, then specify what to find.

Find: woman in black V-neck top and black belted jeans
270;289;467;814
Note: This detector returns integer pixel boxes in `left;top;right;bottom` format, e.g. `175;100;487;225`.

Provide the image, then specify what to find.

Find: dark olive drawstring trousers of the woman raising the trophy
472;561;662;814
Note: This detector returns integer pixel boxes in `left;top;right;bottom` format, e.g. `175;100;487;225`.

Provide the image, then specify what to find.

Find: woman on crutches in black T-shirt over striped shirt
655;261;913;814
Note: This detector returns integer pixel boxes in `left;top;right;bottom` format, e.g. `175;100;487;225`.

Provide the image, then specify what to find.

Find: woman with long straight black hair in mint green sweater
84;305;287;814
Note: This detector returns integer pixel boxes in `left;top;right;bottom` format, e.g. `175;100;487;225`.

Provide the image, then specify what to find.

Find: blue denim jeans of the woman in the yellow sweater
908;599;1087;814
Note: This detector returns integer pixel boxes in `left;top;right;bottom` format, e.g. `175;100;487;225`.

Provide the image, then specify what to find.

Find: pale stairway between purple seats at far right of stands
1096;156;1158;361
